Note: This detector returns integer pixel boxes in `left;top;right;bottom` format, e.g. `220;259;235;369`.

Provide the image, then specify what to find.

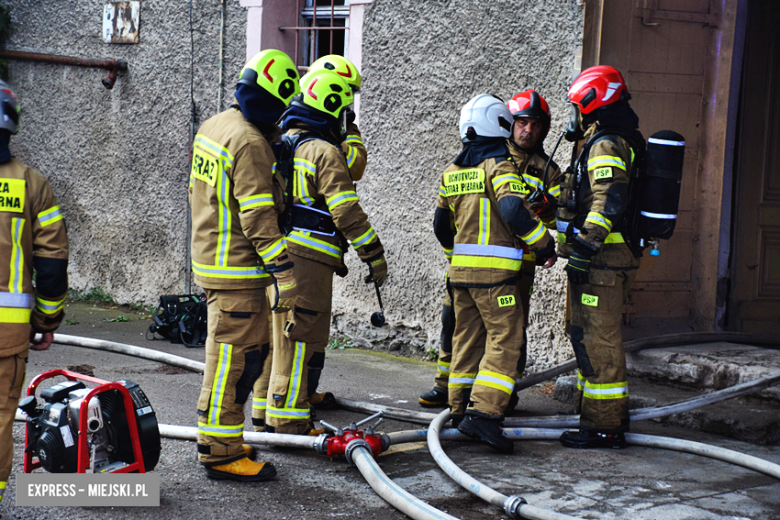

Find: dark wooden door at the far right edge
728;0;780;333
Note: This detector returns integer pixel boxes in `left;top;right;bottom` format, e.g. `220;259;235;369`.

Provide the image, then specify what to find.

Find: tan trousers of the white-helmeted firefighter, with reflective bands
448;283;525;419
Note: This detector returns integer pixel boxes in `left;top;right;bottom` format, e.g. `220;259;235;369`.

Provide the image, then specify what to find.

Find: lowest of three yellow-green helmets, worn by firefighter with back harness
293;69;354;136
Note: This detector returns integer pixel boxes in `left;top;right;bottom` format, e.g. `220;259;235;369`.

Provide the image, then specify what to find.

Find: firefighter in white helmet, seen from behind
434;94;556;453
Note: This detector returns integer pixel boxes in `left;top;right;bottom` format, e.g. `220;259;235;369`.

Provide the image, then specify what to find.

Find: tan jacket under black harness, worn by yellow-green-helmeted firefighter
287;128;383;268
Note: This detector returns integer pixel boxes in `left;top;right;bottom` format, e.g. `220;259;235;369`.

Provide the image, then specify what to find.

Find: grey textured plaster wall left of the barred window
2;0;246;303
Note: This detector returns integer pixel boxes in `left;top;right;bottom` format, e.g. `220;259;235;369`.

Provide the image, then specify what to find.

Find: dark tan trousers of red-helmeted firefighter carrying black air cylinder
569;268;636;433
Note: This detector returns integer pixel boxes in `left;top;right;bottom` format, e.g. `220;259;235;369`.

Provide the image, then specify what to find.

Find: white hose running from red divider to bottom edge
351;446;458;520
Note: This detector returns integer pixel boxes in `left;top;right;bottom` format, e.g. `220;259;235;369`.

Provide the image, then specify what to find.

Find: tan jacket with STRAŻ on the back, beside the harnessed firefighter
189;107;289;289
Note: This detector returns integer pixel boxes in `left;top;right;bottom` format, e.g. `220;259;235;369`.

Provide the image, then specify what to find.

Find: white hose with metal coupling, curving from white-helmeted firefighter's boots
428;410;576;520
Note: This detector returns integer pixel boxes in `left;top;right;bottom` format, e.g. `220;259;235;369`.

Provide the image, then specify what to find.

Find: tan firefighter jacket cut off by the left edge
0;158;68;357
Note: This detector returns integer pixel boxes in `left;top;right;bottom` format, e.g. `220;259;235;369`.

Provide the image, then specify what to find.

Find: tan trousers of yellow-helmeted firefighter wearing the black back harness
266;251;335;434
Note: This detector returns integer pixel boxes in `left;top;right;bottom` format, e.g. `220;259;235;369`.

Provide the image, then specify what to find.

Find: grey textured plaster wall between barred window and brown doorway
334;0;583;370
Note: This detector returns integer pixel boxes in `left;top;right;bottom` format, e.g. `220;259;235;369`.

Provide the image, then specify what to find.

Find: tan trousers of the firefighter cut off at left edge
0;350;27;500
